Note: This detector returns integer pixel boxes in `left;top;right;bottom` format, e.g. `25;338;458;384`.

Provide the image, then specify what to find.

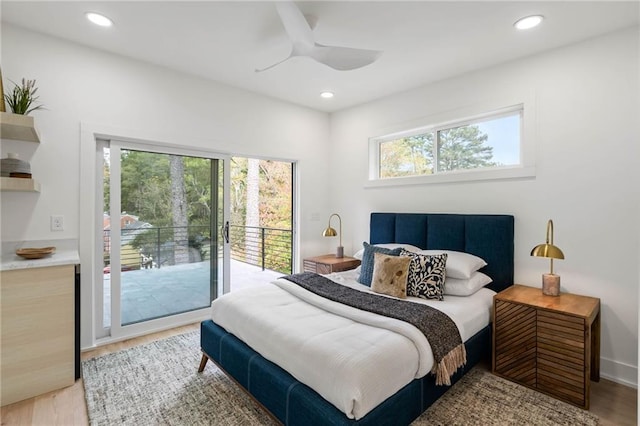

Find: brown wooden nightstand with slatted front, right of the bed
493;285;600;409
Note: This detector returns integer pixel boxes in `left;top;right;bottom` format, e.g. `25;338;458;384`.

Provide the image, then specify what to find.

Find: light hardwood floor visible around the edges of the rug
1;324;638;426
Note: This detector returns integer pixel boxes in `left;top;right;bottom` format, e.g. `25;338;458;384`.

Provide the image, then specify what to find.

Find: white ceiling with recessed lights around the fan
1;0;639;112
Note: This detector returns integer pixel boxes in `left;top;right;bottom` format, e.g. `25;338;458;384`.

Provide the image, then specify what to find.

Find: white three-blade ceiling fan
256;1;382;72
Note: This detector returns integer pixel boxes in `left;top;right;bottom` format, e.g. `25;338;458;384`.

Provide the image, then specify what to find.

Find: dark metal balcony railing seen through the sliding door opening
103;221;293;274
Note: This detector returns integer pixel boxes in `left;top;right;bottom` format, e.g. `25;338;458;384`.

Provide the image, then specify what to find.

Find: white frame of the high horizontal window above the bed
365;97;535;187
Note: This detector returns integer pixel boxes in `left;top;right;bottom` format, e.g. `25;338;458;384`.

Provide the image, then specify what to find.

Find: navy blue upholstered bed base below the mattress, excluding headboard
200;320;491;426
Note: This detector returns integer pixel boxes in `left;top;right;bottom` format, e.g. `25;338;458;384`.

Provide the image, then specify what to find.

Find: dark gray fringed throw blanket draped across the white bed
282;272;467;386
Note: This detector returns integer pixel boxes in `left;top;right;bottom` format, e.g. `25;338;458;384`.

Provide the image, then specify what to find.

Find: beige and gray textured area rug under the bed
82;331;598;426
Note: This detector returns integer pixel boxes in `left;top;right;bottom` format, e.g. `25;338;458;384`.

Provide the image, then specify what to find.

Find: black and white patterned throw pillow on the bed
400;250;447;300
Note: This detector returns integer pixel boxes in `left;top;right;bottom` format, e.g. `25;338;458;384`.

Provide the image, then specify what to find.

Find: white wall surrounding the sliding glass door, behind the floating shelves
1;24;330;347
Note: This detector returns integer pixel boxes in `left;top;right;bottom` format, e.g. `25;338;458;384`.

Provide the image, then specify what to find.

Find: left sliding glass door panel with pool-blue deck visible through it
98;141;229;337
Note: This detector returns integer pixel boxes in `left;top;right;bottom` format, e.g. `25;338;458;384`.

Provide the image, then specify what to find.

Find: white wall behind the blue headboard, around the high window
331;28;640;384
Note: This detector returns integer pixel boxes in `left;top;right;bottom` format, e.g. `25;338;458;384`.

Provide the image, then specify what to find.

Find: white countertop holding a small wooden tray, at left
0;240;80;271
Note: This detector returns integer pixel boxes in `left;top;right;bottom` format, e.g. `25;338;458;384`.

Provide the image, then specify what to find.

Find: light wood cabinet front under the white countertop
0;265;76;406
